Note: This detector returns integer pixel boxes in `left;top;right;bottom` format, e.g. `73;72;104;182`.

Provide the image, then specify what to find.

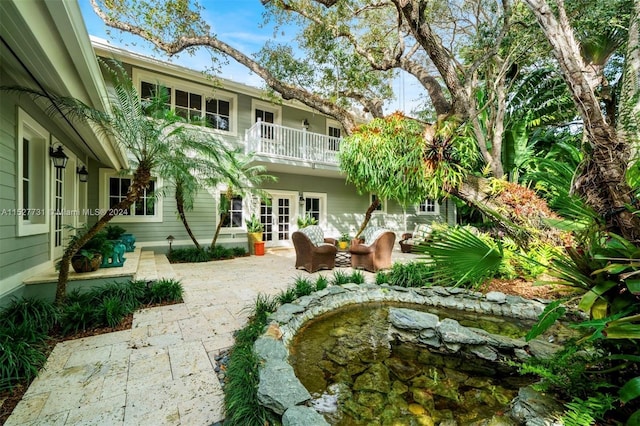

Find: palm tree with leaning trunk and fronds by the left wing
2;60;246;304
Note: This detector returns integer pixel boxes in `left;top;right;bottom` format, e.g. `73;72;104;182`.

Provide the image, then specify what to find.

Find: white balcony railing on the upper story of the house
245;121;341;165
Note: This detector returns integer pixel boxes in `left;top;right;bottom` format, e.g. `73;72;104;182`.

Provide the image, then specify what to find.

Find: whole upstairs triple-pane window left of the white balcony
133;69;237;135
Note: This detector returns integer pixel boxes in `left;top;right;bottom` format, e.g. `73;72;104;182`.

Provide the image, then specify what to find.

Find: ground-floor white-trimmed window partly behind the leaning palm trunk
98;169;163;222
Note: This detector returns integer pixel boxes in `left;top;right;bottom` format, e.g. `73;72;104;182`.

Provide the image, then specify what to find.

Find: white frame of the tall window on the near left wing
15;108;51;237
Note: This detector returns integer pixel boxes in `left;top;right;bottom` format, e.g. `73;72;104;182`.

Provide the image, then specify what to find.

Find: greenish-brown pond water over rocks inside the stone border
290;304;532;426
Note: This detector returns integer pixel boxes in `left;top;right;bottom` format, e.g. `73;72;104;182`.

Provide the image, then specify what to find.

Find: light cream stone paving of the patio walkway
6;249;415;426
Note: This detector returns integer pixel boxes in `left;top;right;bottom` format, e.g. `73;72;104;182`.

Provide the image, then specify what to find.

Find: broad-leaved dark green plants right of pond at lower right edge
524;210;640;425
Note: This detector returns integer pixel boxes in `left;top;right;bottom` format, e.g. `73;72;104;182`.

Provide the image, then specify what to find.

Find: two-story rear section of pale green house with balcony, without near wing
90;39;455;248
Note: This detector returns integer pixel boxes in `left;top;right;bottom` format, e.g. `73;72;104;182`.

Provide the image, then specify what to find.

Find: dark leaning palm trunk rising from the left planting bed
55;165;151;305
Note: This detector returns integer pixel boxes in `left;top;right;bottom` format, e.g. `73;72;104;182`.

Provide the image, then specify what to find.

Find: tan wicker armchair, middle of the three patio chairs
349;227;396;272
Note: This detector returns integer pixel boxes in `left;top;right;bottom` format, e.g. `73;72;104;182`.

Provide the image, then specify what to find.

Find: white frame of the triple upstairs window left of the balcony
131;68;238;136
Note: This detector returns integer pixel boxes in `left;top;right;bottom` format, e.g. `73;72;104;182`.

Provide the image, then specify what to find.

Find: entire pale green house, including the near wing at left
0;0;455;300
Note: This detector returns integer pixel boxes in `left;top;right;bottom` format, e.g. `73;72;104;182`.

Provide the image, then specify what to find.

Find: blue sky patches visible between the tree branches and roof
78;0;422;113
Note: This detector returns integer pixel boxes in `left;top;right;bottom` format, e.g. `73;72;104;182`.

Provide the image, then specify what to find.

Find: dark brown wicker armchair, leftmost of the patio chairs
292;225;338;273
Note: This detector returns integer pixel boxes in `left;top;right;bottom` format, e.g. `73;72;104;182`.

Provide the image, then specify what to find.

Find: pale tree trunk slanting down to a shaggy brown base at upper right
525;0;640;241
